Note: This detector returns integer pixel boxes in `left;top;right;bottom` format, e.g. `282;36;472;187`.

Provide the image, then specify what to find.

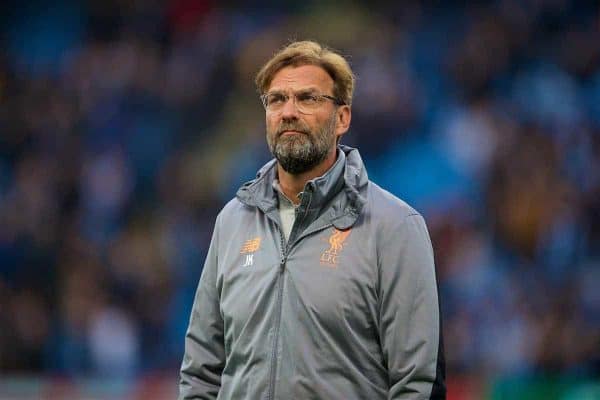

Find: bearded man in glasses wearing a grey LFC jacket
180;41;445;400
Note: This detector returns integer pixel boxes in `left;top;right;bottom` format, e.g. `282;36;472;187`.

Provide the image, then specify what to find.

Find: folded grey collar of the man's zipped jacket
237;145;368;229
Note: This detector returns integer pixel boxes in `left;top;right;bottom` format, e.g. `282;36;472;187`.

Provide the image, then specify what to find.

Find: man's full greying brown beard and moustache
267;113;336;175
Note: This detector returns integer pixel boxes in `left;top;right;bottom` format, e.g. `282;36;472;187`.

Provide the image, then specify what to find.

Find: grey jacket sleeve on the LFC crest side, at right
379;214;446;400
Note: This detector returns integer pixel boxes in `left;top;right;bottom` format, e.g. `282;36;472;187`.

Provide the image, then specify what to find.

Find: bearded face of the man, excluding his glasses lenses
266;65;337;174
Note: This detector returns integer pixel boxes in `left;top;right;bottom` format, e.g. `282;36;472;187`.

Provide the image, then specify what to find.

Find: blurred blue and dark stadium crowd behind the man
0;0;600;400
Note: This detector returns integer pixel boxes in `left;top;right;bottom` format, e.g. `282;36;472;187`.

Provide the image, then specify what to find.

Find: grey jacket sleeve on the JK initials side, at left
179;218;225;400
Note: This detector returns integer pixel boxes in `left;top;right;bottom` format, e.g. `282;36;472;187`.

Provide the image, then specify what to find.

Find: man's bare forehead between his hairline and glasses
268;65;333;93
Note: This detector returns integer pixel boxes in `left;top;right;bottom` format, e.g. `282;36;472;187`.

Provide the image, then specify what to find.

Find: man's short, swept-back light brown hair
255;40;355;105
